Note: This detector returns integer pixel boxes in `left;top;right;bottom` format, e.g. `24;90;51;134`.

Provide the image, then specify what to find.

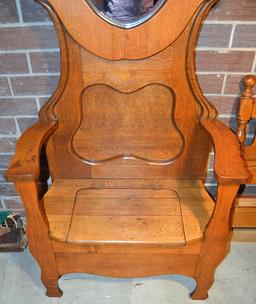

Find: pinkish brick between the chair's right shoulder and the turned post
207;96;239;115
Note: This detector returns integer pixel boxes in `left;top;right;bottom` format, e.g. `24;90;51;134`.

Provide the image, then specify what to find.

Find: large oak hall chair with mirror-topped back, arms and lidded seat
7;0;248;299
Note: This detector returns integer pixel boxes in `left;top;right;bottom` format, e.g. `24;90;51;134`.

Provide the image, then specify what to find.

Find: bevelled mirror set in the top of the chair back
85;0;166;28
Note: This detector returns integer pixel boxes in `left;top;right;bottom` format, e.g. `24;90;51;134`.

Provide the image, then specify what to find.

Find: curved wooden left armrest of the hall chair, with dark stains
6;121;58;182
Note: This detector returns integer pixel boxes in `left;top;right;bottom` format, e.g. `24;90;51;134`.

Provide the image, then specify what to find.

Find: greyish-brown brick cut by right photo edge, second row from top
232;24;256;48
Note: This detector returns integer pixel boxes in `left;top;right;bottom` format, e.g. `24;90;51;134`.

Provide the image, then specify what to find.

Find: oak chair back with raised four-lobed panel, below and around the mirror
40;0;217;178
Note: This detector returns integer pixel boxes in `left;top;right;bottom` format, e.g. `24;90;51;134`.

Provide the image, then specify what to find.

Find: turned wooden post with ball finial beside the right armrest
236;75;256;144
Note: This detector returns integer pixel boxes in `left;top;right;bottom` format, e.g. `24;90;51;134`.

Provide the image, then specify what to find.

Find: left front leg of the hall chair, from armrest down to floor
15;182;62;297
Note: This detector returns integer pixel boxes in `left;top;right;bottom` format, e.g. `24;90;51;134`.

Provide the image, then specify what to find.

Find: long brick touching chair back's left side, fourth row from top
10;76;59;95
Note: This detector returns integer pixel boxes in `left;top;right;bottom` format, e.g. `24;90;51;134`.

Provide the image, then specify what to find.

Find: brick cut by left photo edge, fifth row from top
0;98;37;116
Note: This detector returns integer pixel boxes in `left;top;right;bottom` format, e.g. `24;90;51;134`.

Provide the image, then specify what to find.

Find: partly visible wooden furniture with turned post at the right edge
233;75;256;228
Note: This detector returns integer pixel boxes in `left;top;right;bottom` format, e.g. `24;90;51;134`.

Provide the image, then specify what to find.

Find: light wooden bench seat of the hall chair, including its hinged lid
44;179;214;246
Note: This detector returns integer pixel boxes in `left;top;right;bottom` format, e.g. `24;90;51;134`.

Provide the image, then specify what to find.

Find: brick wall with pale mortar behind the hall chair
0;0;256;215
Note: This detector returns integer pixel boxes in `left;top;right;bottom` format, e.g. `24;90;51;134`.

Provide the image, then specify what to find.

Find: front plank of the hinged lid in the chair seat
68;215;185;244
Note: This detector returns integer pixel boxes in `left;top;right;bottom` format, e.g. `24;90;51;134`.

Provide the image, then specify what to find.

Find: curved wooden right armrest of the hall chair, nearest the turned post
201;119;249;183
